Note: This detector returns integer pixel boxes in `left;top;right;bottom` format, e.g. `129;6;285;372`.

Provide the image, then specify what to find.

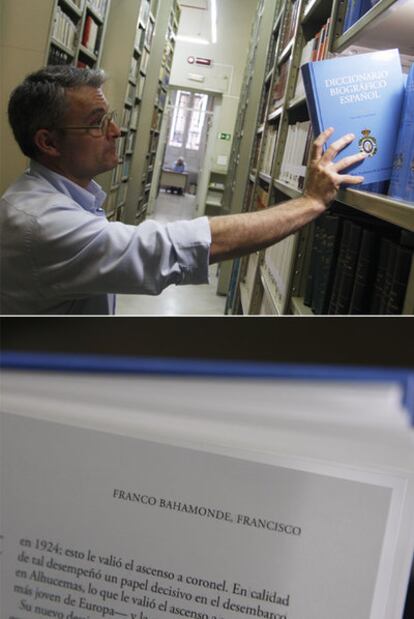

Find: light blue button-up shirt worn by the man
0;161;211;314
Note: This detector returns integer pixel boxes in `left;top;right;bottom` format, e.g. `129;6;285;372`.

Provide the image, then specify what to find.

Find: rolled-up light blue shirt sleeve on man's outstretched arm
31;207;211;298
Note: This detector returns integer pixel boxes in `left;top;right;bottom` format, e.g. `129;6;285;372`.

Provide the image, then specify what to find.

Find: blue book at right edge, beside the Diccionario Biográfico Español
388;65;414;202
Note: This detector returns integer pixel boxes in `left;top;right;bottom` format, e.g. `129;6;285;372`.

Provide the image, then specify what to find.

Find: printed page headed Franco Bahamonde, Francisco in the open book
0;412;403;619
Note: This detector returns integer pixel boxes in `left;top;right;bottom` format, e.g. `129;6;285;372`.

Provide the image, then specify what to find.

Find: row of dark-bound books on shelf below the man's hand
304;213;414;314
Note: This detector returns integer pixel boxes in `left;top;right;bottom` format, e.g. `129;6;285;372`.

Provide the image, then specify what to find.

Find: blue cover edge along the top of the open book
0;351;414;425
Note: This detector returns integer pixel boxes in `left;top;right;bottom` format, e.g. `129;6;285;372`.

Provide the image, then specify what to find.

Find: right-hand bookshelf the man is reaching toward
226;0;414;315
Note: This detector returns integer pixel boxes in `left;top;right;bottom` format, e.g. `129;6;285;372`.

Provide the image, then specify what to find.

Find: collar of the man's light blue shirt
29;159;106;213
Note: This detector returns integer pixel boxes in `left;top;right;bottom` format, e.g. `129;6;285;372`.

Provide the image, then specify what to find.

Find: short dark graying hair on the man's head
8;65;106;159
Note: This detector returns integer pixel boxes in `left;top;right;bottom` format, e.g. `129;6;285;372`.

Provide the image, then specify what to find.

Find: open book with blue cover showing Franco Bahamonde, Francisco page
0;354;414;619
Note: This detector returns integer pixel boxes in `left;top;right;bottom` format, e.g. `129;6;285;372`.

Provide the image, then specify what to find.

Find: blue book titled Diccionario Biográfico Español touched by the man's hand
302;49;404;184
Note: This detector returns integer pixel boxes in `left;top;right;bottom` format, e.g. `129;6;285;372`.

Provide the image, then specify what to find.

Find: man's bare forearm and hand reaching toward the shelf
210;128;366;263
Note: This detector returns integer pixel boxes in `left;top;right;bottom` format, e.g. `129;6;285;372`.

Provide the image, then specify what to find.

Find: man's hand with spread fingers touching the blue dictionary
304;127;367;206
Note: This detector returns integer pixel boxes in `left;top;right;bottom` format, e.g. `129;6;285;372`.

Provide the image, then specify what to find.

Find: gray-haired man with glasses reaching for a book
0;66;364;314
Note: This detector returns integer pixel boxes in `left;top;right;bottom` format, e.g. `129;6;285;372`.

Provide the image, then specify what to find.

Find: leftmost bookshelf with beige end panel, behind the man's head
0;0;111;192
